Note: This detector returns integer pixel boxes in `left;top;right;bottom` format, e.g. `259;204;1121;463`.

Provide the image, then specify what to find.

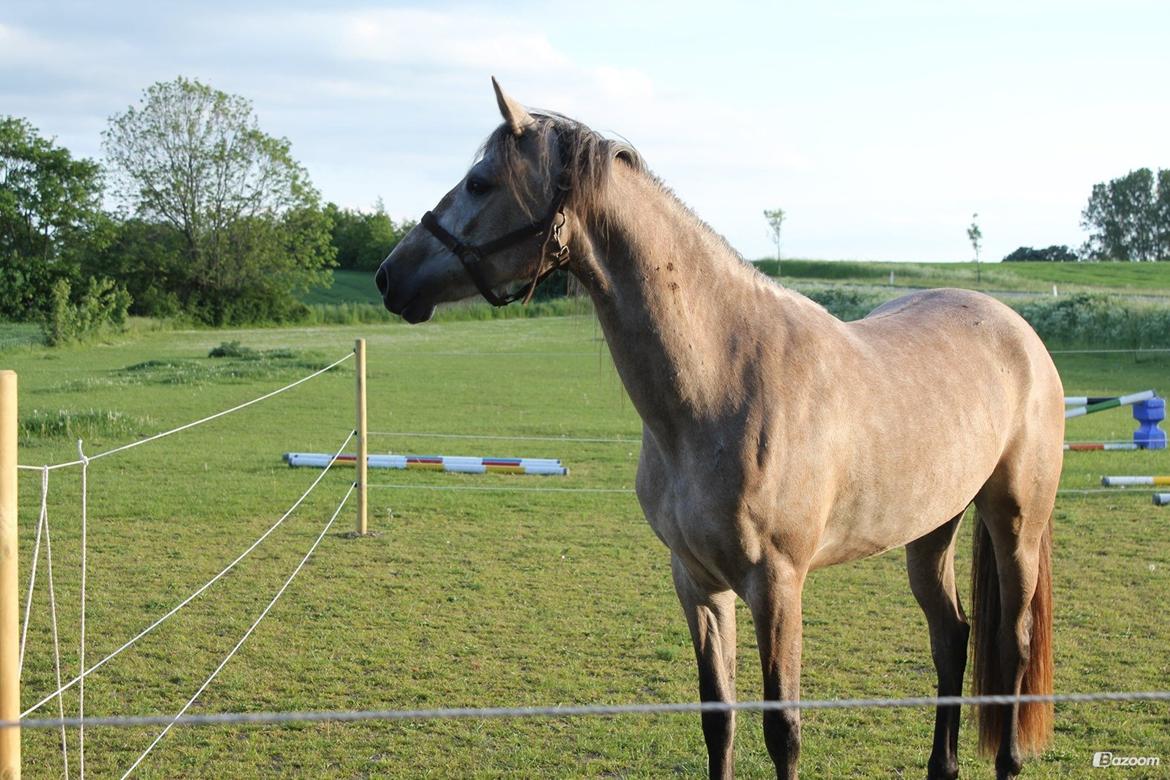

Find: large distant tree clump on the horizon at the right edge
1081;168;1170;261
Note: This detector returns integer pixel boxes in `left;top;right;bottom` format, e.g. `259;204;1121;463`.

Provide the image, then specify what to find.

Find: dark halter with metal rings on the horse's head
421;187;569;306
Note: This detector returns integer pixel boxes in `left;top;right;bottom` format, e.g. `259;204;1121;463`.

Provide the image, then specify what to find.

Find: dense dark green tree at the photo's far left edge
0;117;111;319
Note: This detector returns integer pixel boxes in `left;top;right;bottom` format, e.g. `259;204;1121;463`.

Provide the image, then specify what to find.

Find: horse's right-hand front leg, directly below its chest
745;560;805;780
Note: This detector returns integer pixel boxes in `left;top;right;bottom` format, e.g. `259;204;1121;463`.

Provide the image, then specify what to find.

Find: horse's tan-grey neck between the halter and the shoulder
572;165;800;441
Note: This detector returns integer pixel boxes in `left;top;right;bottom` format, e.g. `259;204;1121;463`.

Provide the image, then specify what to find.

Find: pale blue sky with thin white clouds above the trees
0;0;1170;262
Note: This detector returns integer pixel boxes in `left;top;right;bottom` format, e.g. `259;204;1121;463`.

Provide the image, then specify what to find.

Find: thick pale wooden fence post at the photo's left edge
0;371;20;780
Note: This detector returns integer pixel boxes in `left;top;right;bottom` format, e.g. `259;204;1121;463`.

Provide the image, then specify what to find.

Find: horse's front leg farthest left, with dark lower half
670;555;736;779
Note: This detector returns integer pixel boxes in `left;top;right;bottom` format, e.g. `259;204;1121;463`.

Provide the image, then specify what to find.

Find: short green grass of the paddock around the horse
0;308;1170;778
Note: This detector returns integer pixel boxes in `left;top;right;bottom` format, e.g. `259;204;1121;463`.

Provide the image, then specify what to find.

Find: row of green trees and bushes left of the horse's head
0;77;413;340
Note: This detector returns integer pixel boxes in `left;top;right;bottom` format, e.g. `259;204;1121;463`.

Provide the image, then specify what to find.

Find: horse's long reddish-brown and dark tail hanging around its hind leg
971;513;1053;755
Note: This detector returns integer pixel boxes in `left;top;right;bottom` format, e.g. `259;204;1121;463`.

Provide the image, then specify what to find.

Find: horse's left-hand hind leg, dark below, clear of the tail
906;515;970;780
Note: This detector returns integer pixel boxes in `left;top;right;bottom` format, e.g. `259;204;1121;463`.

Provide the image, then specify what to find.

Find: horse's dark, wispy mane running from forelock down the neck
477;111;749;265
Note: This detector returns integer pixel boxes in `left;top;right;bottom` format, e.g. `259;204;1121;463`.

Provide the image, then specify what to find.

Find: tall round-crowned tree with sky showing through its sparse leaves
103;77;335;324
